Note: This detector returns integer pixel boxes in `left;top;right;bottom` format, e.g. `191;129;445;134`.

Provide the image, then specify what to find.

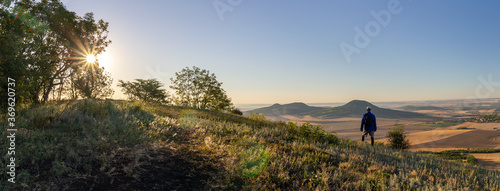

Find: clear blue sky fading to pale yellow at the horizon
63;0;500;104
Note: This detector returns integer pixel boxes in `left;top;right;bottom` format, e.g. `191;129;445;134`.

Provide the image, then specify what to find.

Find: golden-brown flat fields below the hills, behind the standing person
281;115;500;170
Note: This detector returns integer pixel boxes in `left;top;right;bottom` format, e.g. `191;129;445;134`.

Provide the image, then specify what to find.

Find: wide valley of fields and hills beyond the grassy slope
245;99;500;170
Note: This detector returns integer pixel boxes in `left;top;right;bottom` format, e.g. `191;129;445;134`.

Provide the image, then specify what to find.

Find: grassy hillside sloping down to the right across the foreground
0;100;500;190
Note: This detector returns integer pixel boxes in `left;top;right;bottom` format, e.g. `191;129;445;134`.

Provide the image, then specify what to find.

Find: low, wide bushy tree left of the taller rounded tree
118;79;169;103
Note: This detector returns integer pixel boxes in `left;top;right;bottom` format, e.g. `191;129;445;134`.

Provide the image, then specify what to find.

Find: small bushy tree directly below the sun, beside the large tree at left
70;63;115;98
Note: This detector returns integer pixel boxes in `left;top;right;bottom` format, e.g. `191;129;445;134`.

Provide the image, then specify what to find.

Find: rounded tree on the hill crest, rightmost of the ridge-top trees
170;66;232;110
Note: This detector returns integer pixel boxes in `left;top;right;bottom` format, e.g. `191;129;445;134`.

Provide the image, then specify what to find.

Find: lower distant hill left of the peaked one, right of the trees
245;102;326;116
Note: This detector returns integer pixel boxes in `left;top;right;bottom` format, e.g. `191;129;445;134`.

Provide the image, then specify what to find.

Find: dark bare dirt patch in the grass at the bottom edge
92;144;216;190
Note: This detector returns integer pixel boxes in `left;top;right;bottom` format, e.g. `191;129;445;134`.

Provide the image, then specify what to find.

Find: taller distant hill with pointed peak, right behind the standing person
306;100;432;118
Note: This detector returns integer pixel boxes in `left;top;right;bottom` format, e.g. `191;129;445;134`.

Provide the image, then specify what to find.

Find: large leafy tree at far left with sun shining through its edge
0;0;111;103
